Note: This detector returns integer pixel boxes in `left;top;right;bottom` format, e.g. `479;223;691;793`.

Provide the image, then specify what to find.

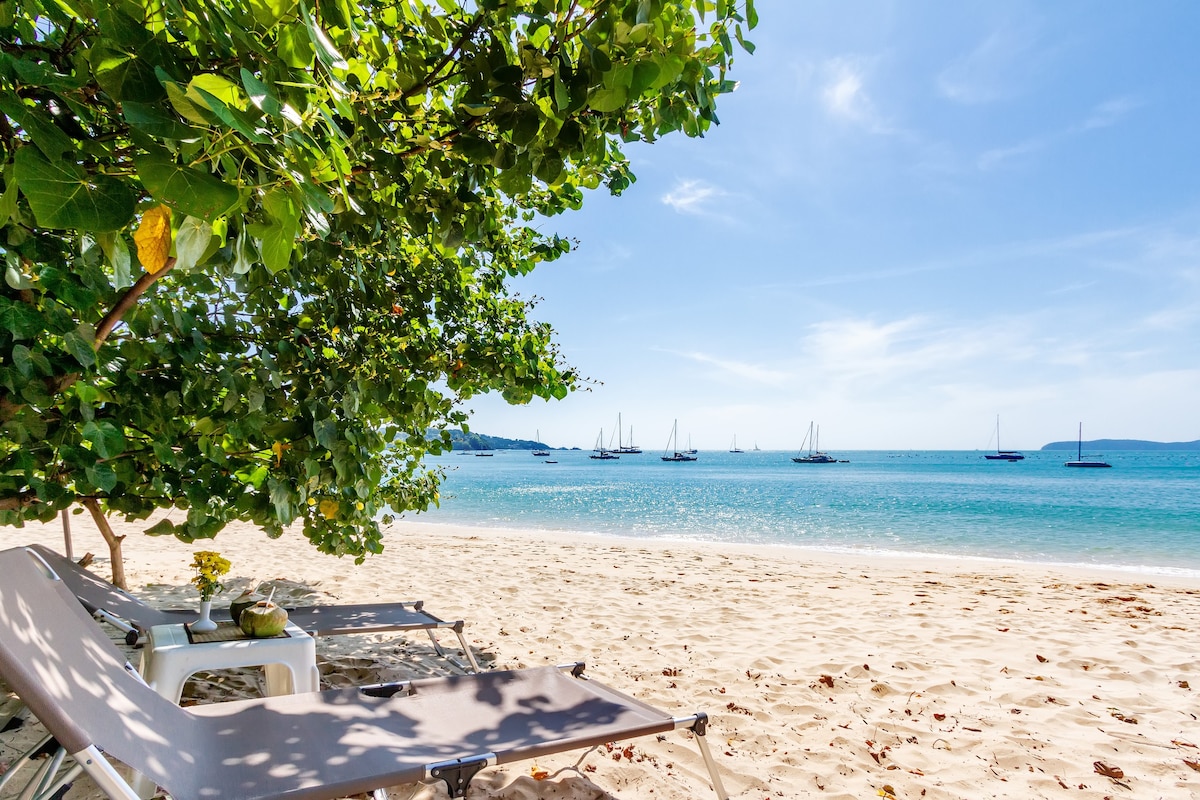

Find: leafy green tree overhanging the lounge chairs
0;0;756;583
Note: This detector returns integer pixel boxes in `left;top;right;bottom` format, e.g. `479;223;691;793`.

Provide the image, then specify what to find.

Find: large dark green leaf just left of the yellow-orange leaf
13;148;137;231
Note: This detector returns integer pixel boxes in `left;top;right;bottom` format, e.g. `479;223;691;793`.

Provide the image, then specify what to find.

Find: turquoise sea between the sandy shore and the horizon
416;450;1200;578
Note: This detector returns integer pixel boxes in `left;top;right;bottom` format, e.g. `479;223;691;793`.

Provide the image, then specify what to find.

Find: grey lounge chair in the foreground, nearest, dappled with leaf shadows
0;548;728;800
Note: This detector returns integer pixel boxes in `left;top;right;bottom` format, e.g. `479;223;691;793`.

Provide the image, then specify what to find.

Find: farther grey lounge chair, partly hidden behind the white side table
29;545;479;672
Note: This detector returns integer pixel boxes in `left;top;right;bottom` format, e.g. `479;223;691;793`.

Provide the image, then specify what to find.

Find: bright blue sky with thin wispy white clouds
467;0;1200;451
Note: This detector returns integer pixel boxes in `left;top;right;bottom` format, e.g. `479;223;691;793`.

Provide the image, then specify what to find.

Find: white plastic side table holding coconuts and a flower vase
140;622;320;704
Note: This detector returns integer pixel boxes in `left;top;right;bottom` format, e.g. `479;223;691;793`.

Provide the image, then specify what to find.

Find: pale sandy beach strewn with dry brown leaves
0;516;1200;800
